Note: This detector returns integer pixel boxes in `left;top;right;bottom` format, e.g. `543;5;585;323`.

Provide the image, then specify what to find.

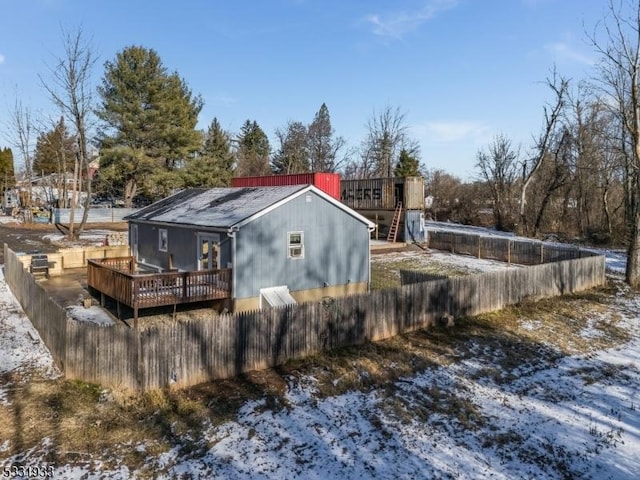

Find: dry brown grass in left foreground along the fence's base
0;371;284;470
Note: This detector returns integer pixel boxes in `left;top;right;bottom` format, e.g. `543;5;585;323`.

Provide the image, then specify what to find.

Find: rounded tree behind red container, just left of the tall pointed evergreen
271;122;309;174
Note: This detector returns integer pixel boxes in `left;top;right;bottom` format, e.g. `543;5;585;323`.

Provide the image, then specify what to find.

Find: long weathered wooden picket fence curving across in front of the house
5;240;605;390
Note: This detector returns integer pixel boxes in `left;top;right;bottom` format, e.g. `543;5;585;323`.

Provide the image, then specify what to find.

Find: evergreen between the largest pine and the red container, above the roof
182;118;235;187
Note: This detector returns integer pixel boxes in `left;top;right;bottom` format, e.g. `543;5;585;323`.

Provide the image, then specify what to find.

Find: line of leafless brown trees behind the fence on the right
426;72;624;245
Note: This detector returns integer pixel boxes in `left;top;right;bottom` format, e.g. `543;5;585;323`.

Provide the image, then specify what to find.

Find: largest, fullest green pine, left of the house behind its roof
97;46;202;206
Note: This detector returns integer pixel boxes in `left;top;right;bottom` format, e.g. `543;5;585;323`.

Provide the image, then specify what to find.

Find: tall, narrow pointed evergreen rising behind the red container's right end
307;103;345;172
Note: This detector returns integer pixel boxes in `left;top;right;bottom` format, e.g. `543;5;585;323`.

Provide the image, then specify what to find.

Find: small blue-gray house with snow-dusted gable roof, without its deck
125;185;374;311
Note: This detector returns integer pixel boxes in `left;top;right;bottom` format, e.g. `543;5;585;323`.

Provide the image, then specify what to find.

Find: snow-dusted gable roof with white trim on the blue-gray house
124;185;373;228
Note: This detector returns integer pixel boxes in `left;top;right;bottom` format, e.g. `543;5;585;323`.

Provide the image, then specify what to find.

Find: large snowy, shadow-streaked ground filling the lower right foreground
179;319;640;479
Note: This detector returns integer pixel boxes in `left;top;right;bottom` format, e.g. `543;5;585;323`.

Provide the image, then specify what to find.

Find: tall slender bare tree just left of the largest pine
40;29;97;238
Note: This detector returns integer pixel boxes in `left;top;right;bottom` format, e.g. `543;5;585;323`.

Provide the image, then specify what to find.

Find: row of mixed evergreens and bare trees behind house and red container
3;36;420;222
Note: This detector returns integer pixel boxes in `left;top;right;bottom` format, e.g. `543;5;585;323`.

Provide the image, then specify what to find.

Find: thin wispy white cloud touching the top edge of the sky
365;0;458;38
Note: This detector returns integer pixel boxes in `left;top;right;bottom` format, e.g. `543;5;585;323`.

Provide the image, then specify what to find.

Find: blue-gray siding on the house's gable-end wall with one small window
234;192;369;298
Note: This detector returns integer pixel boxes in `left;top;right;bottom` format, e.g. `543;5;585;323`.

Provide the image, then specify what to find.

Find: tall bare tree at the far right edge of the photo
589;0;640;289
